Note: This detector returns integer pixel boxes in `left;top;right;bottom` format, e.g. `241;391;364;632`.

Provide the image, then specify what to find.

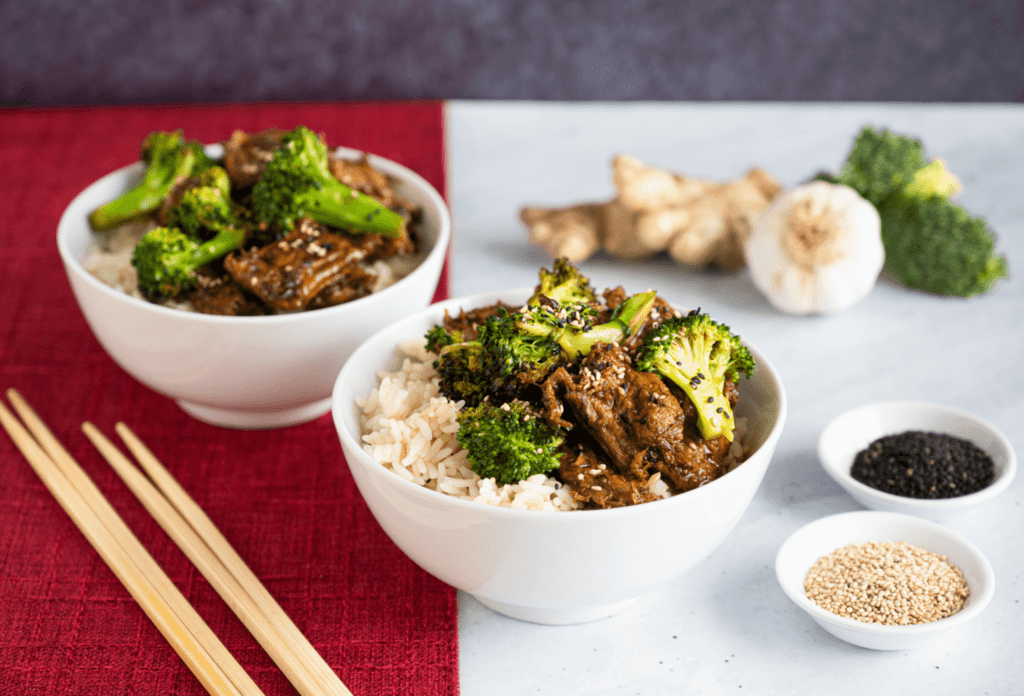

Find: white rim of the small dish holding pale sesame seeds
775;510;995;638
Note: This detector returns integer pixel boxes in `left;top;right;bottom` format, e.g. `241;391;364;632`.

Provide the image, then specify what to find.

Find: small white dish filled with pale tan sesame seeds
775;511;995;650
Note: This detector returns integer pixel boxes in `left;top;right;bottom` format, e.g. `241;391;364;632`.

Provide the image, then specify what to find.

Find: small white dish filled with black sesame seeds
818;401;1017;521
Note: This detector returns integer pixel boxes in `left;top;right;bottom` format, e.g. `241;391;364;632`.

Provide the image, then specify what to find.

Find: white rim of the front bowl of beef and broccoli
331;288;788;524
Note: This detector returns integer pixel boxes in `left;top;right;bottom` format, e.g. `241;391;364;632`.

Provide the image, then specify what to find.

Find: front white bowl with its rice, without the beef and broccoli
332;289;786;624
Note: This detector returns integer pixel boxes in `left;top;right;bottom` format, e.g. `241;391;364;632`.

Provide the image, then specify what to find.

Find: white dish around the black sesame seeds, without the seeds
818;401;1017;521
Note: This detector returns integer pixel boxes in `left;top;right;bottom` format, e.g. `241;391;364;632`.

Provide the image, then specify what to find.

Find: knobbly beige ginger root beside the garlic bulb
519;155;782;270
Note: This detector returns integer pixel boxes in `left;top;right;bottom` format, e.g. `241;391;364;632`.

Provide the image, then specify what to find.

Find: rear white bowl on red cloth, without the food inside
57;149;452;428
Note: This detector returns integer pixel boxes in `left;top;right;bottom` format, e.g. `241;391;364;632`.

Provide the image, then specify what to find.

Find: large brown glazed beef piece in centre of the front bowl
542;343;729;503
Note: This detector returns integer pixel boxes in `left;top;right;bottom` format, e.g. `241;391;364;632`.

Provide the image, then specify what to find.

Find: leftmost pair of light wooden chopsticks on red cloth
0;389;262;696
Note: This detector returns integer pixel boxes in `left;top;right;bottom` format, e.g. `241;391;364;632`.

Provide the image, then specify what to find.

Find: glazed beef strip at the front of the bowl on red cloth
224;219;385;312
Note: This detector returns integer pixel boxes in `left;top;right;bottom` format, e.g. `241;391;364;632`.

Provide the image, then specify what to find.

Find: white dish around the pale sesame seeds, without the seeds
775;510;995;650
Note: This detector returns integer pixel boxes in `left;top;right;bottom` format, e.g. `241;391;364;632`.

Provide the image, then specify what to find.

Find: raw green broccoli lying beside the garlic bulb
830;127;1009;297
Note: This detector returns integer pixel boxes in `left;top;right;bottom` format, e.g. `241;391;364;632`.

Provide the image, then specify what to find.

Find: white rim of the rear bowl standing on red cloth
56;143;452;325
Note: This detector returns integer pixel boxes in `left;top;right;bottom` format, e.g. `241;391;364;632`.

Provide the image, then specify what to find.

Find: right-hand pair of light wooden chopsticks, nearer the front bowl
82;423;351;696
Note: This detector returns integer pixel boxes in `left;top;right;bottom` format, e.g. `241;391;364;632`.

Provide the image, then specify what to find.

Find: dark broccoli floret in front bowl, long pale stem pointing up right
428;292;656;406
